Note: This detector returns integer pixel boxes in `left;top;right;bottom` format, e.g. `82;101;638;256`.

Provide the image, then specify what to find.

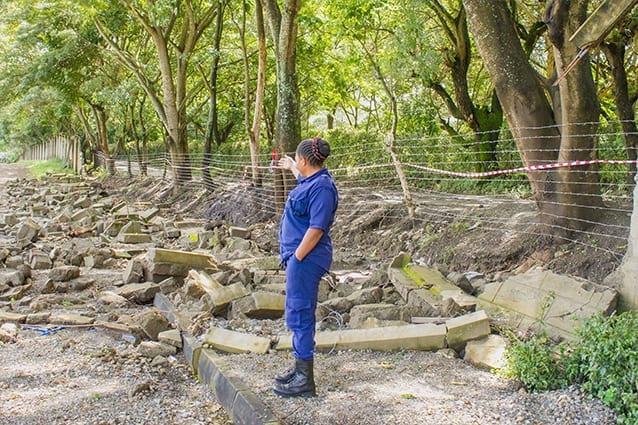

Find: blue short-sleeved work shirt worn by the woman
279;168;339;271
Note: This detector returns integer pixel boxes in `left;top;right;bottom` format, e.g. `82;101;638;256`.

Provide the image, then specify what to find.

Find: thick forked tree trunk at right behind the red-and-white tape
463;0;603;234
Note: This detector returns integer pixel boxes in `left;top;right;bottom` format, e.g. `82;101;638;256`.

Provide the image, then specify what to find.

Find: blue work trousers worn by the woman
286;255;326;360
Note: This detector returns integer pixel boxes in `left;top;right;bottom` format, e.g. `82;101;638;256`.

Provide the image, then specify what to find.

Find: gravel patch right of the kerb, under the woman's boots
228;350;615;425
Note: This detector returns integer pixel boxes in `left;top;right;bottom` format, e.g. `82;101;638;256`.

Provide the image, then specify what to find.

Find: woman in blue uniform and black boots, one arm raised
274;137;338;397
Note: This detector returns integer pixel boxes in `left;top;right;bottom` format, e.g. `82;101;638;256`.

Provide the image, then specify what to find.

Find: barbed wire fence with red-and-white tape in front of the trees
61;123;638;258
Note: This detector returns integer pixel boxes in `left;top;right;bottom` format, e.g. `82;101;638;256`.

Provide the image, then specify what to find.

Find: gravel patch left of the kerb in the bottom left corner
0;329;232;425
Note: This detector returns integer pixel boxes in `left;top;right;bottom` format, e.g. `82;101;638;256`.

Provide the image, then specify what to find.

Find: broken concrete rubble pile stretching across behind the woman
0;175;617;368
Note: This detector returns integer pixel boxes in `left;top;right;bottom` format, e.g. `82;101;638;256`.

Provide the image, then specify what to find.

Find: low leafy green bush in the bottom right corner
503;311;638;424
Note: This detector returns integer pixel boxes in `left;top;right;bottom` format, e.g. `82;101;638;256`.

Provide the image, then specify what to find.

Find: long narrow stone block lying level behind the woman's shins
276;324;446;351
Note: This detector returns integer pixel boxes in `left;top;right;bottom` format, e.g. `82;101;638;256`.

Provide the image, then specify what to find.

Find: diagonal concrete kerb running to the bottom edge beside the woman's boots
155;294;280;425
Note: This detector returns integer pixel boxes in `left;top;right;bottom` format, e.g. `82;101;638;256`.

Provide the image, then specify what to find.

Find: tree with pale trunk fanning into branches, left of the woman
95;0;217;184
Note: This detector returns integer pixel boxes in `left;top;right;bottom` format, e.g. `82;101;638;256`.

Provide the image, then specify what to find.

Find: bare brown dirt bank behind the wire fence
101;176;629;283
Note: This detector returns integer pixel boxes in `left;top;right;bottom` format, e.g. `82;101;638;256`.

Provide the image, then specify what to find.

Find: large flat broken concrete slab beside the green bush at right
478;269;618;339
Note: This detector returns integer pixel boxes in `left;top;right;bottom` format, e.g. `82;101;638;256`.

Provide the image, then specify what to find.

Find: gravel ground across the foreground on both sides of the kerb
0;322;615;425
